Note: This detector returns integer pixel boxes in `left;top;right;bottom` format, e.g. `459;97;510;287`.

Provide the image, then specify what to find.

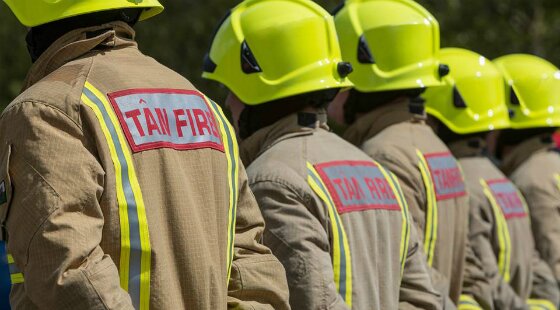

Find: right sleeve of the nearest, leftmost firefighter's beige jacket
228;163;290;310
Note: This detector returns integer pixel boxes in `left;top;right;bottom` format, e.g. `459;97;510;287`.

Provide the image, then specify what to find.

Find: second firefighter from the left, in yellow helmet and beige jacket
204;0;441;310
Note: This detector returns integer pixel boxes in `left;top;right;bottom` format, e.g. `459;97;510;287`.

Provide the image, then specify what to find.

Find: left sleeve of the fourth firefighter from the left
463;191;527;309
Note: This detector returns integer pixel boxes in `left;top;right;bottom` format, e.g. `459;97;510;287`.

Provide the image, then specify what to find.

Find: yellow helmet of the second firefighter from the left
202;0;352;105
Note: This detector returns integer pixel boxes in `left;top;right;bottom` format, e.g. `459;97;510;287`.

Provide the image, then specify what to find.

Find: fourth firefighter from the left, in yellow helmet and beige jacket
423;48;560;310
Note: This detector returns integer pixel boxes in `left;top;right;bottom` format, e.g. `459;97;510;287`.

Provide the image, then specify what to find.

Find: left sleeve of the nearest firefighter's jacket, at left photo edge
0;102;132;309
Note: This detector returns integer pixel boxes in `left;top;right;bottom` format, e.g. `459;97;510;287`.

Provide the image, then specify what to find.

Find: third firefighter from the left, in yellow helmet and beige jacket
329;0;489;304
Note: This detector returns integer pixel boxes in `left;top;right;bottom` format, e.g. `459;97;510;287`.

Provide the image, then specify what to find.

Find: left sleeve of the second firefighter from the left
251;177;348;309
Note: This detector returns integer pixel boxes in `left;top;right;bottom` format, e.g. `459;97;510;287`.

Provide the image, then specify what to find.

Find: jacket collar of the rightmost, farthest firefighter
502;135;554;175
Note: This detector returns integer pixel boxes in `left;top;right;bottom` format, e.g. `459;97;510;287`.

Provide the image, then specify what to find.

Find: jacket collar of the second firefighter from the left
239;109;329;166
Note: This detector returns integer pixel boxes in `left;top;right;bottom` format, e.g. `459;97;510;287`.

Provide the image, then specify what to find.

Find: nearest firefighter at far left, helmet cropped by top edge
0;0;289;310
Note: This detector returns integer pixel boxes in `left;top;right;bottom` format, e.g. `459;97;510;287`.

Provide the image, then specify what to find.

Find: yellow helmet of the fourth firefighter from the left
423;48;509;134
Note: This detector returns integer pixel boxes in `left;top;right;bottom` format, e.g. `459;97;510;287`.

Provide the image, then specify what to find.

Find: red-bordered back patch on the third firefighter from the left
424;152;467;200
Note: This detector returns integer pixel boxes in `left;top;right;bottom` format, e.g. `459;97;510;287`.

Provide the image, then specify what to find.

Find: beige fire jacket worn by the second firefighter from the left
241;110;441;310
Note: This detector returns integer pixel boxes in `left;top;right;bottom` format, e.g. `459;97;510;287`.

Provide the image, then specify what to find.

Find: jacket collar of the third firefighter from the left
343;98;426;146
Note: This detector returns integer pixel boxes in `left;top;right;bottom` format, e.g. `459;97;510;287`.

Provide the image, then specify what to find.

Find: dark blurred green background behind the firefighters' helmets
0;0;560;109
